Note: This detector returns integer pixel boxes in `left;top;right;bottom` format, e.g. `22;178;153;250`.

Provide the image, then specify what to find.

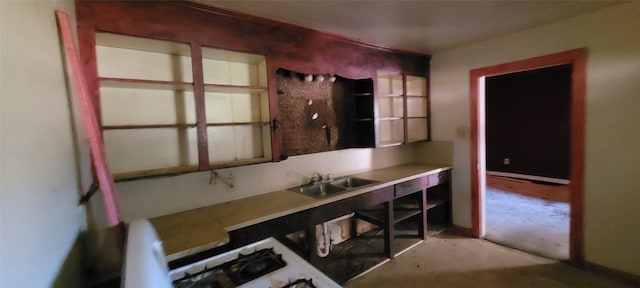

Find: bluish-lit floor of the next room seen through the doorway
485;187;570;259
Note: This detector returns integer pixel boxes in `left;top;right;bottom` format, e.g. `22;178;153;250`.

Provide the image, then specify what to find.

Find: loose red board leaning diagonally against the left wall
56;11;120;226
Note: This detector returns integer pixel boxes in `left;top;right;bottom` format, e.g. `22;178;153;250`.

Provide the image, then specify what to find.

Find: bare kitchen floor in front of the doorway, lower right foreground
344;232;632;288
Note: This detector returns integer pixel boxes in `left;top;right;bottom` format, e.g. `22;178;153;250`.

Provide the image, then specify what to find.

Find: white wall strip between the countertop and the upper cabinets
116;145;413;222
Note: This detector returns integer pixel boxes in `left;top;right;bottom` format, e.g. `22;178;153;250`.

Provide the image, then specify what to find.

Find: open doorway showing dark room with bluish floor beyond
485;64;572;259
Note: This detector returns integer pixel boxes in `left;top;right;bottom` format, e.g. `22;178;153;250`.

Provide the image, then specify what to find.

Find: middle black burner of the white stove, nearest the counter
224;248;287;285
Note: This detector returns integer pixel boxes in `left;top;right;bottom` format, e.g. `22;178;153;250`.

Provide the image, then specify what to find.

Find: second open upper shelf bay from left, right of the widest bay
202;47;271;167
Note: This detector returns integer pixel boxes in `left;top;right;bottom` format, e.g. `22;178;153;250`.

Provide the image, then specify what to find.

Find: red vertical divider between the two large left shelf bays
191;43;209;170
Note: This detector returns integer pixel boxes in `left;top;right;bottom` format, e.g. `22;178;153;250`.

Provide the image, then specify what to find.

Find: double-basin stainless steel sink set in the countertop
288;176;378;198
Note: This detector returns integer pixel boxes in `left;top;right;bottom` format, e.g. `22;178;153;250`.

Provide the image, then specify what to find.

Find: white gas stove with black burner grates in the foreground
123;220;340;288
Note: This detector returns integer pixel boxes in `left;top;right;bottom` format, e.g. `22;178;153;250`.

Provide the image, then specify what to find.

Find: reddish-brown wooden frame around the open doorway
469;48;587;265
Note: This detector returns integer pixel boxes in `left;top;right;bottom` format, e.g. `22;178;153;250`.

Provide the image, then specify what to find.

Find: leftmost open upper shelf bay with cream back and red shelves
96;33;198;179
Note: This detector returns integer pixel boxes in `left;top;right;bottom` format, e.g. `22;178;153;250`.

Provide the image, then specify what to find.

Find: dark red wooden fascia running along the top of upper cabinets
76;1;430;79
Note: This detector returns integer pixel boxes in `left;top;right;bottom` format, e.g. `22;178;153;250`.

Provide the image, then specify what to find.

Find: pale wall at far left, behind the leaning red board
0;0;90;287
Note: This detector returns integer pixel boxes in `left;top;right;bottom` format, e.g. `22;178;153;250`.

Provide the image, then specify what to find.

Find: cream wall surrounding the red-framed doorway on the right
431;2;640;275
